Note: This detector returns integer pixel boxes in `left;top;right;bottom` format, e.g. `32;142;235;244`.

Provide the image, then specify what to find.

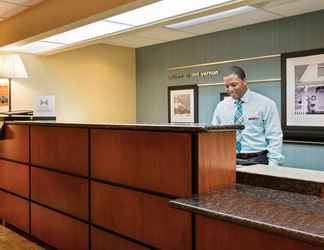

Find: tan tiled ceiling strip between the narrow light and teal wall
101;0;324;48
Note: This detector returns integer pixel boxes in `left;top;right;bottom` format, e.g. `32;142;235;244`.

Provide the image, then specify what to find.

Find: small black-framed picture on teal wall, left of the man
168;85;198;123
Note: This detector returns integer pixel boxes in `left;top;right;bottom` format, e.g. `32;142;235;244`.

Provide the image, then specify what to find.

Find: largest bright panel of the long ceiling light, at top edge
106;0;232;26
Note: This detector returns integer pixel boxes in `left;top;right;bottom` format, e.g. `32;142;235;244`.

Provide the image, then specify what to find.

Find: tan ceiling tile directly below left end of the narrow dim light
136;27;195;42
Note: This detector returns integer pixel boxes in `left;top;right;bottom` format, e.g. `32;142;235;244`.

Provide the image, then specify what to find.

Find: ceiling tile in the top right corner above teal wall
263;0;324;16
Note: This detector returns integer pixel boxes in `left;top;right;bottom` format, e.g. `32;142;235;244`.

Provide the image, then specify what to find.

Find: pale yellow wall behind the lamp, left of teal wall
0;44;136;122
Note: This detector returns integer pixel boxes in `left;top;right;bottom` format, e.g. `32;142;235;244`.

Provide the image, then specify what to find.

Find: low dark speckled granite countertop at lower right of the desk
170;184;324;246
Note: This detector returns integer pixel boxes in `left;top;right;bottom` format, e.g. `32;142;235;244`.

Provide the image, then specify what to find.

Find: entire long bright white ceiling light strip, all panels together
0;0;233;54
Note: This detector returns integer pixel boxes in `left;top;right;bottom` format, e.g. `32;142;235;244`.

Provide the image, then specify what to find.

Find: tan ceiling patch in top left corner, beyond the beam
0;0;44;21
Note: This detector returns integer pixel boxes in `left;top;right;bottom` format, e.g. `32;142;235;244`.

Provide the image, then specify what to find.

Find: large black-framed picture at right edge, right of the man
281;49;324;142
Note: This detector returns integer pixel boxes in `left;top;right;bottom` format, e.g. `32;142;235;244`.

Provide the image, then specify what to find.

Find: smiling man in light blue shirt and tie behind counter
212;66;283;166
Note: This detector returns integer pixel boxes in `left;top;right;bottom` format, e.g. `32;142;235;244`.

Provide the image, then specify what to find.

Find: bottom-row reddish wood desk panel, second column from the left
31;203;89;250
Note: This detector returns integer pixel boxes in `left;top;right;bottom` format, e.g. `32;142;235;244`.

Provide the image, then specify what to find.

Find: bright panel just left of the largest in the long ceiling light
41;21;132;44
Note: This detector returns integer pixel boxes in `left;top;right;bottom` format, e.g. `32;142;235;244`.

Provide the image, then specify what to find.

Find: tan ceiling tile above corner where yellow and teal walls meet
103;35;163;48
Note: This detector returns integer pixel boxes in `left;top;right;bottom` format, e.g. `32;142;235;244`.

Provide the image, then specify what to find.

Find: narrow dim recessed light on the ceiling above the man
165;6;256;29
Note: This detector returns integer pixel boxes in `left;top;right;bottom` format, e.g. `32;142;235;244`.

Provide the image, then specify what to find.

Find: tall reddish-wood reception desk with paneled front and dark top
0;121;240;250
